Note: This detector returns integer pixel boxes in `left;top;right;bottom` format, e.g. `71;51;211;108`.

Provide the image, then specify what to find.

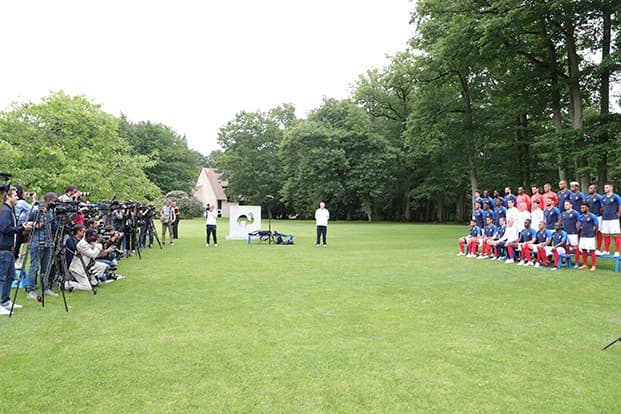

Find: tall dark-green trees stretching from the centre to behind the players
216;0;621;221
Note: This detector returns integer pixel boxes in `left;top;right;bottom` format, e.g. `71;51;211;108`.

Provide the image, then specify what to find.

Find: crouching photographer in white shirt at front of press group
66;229;114;290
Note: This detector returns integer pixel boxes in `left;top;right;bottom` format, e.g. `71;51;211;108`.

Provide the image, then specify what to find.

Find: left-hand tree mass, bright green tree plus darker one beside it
0;92;205;200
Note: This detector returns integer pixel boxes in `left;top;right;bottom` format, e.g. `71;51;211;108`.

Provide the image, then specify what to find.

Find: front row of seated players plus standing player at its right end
458;203;598;271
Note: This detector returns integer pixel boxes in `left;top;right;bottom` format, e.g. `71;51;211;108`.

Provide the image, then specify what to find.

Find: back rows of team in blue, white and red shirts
472;181;621;256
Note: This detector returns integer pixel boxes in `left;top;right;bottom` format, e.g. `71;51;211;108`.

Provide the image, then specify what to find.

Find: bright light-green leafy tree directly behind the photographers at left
0;92;160;200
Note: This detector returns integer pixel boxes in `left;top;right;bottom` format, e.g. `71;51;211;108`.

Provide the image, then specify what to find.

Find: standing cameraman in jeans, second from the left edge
26;193;58;300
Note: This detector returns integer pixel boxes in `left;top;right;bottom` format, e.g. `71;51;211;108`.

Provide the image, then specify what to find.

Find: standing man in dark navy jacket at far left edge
0;187;32;315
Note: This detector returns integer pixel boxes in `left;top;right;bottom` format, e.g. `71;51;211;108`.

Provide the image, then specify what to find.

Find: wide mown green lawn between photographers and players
0;221;621;413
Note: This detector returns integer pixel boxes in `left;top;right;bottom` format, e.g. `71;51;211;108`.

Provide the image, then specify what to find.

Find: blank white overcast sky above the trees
0;0;414;155
